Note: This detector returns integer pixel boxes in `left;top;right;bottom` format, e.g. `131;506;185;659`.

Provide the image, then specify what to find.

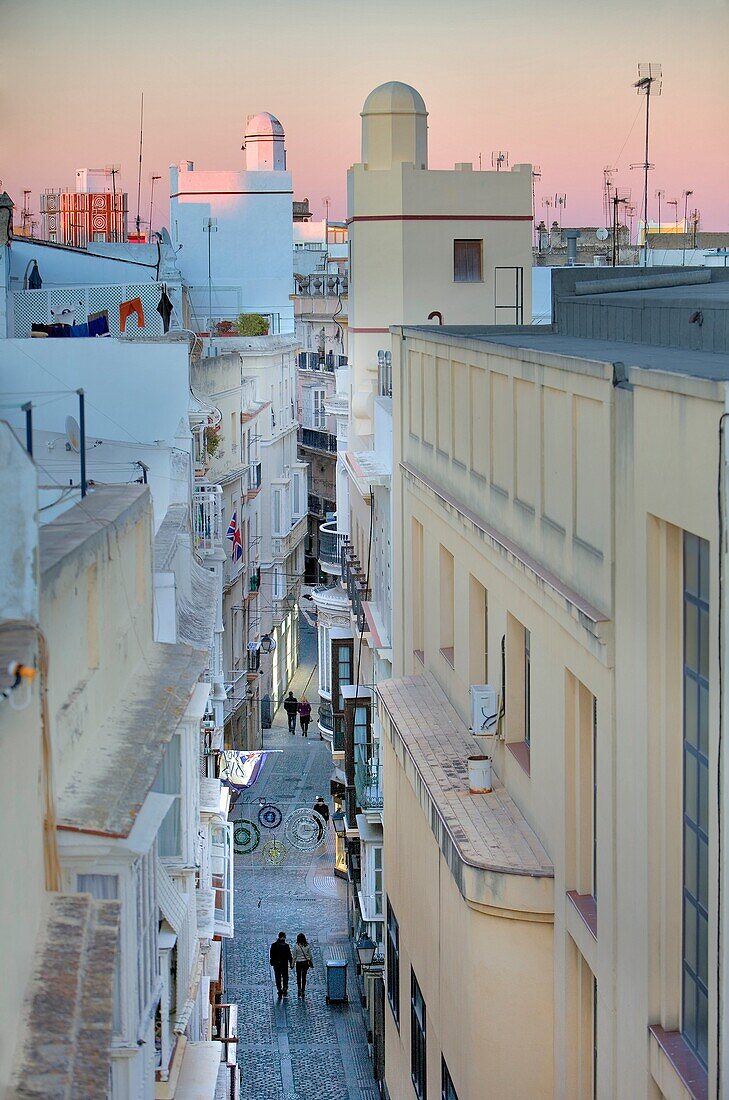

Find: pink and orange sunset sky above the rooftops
0;0;729;229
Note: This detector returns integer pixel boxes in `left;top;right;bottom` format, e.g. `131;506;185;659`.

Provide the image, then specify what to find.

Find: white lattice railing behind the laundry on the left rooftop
13;283;164;339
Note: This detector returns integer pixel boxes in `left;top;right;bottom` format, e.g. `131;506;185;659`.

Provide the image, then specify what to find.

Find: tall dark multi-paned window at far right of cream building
681;531;709;1068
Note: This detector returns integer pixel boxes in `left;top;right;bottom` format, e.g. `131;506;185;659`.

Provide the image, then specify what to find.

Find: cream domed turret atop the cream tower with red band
362;80;428;169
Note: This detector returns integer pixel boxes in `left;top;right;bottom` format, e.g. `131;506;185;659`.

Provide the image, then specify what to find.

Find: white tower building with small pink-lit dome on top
169;113;294;334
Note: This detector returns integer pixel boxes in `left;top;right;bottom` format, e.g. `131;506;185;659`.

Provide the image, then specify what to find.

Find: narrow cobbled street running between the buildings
225;619;377;1100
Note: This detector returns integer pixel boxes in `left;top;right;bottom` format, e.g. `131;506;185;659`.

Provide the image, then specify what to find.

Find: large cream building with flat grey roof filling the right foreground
378;270;729;1100
